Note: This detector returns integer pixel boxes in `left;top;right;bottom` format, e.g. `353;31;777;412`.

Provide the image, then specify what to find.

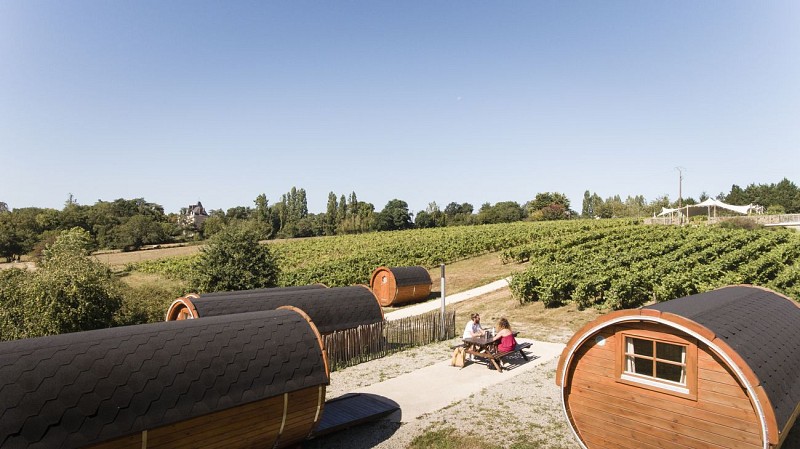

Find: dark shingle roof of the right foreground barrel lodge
644;286;800;429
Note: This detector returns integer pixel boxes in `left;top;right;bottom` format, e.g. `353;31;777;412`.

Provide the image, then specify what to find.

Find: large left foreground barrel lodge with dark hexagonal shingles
0;310;329;449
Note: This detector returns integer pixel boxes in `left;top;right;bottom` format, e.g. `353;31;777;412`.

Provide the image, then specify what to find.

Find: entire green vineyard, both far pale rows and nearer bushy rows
129;220;800;309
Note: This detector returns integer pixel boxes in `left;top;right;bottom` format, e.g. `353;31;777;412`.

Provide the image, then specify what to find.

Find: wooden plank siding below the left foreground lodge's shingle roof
86;386;325;449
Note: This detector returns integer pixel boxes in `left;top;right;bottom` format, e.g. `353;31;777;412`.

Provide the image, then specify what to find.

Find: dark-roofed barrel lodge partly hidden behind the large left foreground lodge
167;285;383;335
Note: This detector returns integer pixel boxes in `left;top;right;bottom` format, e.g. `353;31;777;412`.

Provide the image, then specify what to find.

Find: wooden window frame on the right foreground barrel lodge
616;329;697;401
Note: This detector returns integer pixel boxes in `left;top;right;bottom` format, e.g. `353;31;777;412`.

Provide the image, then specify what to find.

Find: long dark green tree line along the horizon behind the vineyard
0;179;800;261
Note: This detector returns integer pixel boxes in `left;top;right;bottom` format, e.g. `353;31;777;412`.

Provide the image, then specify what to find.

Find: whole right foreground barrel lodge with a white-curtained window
556;285;800;449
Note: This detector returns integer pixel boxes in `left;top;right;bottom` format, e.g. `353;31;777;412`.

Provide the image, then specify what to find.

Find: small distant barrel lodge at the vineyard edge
370;266;431;307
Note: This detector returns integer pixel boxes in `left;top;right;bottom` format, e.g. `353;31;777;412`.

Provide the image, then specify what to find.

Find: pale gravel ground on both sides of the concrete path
303;340;578;449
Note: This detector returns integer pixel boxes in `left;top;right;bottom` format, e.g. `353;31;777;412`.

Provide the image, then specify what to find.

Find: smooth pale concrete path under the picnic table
356;338;565;422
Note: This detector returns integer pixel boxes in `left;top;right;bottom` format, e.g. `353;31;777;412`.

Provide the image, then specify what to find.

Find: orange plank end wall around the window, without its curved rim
565;323;762;449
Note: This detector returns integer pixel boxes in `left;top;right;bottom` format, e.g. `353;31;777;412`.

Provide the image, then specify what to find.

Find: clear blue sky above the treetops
0;0;800;212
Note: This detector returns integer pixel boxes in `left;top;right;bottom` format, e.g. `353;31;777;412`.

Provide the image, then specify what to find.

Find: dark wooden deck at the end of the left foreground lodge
311;393;400;438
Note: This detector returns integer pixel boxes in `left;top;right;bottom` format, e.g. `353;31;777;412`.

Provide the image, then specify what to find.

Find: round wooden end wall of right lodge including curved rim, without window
556;310;774;449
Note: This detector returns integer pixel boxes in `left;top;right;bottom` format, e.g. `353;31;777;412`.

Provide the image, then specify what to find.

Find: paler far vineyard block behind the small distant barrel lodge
128;220;630;287
